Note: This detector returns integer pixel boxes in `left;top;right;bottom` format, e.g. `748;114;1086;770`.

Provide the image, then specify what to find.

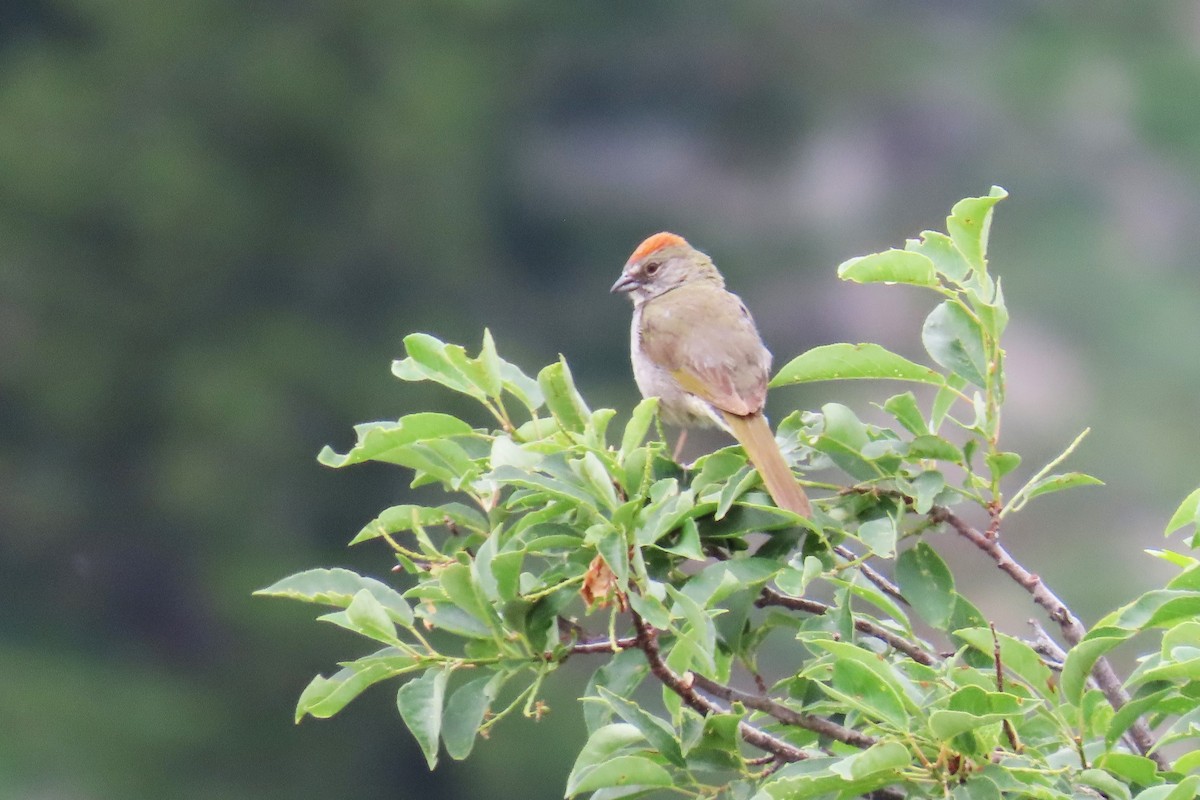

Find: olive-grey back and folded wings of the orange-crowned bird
641;284;770;416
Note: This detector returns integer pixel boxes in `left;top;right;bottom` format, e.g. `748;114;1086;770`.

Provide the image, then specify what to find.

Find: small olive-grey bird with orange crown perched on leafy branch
612;233;812;518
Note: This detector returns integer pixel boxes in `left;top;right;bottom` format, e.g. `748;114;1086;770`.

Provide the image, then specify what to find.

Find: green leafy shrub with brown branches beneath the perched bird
259;188;1200;800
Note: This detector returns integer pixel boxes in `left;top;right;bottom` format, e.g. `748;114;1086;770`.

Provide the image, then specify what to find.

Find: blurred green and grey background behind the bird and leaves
7;0;1200;800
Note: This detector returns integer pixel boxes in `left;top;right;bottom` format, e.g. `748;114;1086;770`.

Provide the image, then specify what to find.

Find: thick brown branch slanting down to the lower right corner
929;506;1170;771
